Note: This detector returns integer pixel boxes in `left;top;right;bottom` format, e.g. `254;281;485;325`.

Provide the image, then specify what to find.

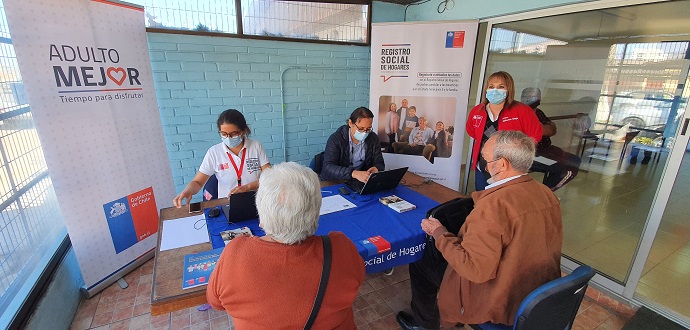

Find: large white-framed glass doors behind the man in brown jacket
470;1;690;325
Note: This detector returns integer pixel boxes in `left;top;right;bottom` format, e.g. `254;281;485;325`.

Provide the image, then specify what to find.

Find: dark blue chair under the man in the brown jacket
471;265;595;330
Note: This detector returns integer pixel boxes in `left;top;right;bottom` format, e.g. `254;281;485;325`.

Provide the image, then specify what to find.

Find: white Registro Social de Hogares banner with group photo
369;21;479;190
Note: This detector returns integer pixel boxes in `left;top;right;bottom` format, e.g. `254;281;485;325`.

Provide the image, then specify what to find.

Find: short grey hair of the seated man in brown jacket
491;131;535;173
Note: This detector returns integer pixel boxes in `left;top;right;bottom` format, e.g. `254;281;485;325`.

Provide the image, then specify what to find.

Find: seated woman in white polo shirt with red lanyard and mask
173;109;271;208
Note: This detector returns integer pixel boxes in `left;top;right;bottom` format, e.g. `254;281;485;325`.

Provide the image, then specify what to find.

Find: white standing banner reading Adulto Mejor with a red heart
4;0;175;290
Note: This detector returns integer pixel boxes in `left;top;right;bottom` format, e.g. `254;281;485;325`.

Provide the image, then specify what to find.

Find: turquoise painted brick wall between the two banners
148;33;370;196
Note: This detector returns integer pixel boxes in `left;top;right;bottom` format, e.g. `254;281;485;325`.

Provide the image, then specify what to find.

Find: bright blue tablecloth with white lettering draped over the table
204;184;439;273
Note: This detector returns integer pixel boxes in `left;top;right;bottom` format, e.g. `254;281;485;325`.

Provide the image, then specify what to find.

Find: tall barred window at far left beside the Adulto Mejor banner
0;4;65;326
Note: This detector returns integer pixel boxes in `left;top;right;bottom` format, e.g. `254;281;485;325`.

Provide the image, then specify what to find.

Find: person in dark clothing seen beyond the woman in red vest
520;87;580;191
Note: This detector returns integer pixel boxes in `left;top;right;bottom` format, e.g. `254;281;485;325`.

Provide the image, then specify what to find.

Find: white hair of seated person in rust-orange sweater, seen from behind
256;162;321;244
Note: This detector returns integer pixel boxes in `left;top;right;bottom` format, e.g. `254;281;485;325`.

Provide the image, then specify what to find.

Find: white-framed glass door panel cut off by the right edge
626;60;690;322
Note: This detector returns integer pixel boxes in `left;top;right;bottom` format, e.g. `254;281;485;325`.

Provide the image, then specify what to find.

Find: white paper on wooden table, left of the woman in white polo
161;213;209;251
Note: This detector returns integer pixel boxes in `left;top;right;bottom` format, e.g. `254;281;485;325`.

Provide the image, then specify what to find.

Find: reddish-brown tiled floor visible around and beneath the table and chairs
71;260;626;330
